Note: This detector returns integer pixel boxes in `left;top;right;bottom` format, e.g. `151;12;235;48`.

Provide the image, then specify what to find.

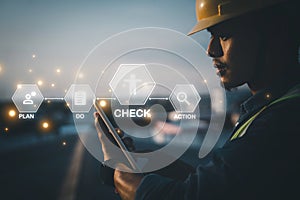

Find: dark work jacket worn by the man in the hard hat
136;82;300;200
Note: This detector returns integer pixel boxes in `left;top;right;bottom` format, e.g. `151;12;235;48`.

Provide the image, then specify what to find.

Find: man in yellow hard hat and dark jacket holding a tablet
96;0;300;199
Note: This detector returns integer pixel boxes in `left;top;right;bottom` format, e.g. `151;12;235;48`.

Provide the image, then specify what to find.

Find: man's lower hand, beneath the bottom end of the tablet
114;169;143;200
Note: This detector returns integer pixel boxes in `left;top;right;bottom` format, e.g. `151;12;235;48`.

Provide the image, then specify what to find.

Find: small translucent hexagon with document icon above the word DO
64;84;95;113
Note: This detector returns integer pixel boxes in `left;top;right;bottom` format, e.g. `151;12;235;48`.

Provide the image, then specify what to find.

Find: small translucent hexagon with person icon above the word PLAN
12;84;44;113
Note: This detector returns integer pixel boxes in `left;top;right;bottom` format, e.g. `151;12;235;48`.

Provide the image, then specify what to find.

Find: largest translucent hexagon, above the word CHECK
109;64;155;105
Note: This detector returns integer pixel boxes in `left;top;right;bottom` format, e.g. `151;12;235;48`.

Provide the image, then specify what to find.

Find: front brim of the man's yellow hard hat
188;14;238;36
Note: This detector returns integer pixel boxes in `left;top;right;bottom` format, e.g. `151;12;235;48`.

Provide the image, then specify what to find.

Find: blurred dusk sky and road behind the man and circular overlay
0;0;249;199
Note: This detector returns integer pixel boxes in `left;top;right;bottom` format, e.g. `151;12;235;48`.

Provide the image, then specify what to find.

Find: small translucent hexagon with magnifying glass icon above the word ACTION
169;84;201;113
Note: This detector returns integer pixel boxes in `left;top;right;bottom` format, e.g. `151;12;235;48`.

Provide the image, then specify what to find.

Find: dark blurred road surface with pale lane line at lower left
0;135;118;200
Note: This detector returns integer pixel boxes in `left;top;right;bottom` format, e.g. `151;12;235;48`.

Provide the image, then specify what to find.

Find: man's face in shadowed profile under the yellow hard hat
207;20;261;89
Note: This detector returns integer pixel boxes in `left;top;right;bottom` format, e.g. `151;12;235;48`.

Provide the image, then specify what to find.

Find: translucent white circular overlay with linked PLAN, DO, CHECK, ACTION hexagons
12;28;226;172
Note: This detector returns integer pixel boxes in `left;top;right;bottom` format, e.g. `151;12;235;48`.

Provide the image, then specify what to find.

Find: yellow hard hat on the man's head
188;0;288;35
